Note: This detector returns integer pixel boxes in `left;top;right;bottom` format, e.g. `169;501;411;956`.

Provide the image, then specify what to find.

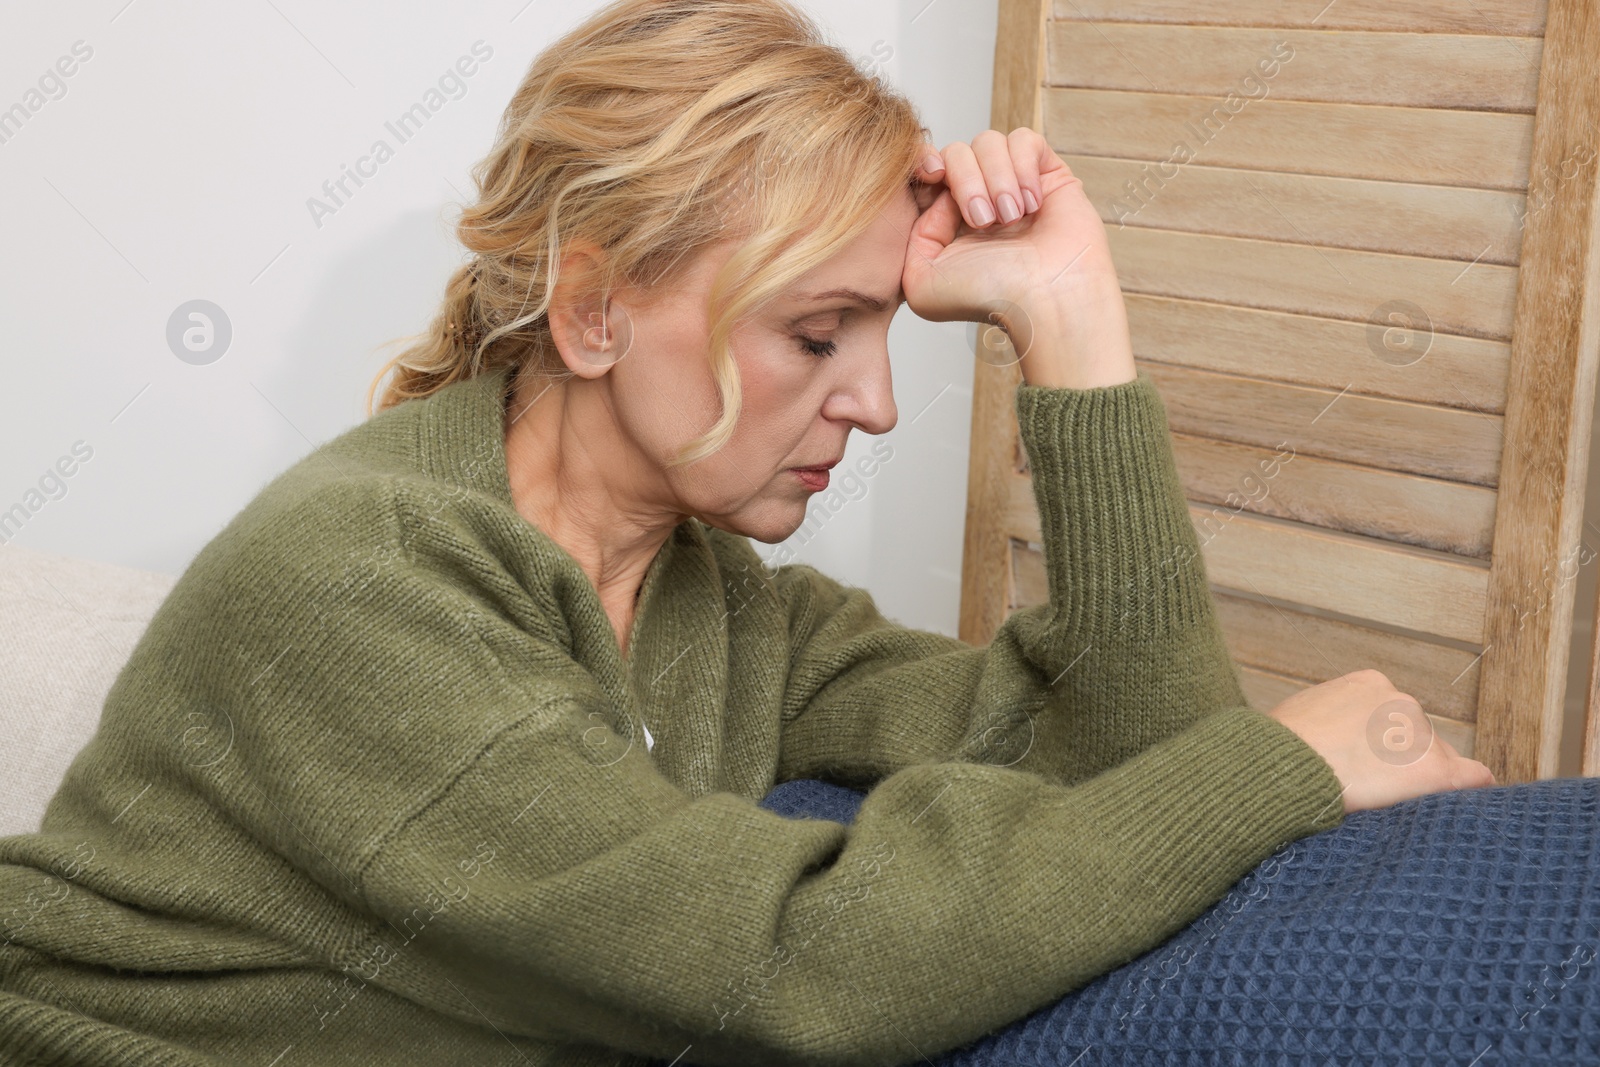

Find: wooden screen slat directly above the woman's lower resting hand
1213;589;1478;723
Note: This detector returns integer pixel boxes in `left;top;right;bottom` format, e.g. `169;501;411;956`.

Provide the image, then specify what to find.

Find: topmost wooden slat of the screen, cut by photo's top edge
1051;0;1546;37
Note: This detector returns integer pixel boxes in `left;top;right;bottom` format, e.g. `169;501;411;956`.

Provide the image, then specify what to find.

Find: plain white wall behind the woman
0;0;995;633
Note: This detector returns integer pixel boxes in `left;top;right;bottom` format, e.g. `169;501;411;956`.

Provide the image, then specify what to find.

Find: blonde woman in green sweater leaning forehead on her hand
0;0;1587;1067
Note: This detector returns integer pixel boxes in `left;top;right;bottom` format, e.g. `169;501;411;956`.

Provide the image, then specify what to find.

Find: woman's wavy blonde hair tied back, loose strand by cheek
366;0;928;464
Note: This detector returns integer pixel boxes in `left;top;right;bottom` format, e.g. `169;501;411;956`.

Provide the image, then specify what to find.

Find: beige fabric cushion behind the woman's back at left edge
0;544;178;837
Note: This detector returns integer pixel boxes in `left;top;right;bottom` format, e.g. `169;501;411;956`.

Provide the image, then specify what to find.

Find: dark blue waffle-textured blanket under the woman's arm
762;777;1600;1067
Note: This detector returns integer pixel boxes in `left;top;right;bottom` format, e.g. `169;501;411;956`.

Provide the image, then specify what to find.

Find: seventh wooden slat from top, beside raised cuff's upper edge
1139;362;1501;486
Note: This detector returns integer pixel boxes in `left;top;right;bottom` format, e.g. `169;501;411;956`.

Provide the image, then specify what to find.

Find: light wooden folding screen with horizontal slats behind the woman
962;0;1600;782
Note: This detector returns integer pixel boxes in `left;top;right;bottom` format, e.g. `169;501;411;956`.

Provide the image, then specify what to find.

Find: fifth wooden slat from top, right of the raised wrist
1107;226;1517;341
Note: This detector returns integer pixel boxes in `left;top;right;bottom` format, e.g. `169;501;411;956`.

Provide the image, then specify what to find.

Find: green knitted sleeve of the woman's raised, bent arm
778;371;1248;785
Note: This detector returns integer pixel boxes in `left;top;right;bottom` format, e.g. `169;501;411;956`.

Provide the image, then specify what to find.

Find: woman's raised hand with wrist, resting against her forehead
901;126;1134;389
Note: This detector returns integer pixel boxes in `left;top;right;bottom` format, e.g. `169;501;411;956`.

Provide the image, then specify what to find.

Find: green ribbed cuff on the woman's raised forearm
1016;370;1211;640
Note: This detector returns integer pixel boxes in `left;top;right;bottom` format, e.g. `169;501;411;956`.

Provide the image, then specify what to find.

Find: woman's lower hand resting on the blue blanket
1267;670;1494;813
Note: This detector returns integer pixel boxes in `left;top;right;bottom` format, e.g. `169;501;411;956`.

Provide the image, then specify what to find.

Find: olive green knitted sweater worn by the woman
0;363;1342;1067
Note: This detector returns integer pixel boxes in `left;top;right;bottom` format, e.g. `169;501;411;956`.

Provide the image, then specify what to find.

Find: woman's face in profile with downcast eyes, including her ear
605;190;918;544
